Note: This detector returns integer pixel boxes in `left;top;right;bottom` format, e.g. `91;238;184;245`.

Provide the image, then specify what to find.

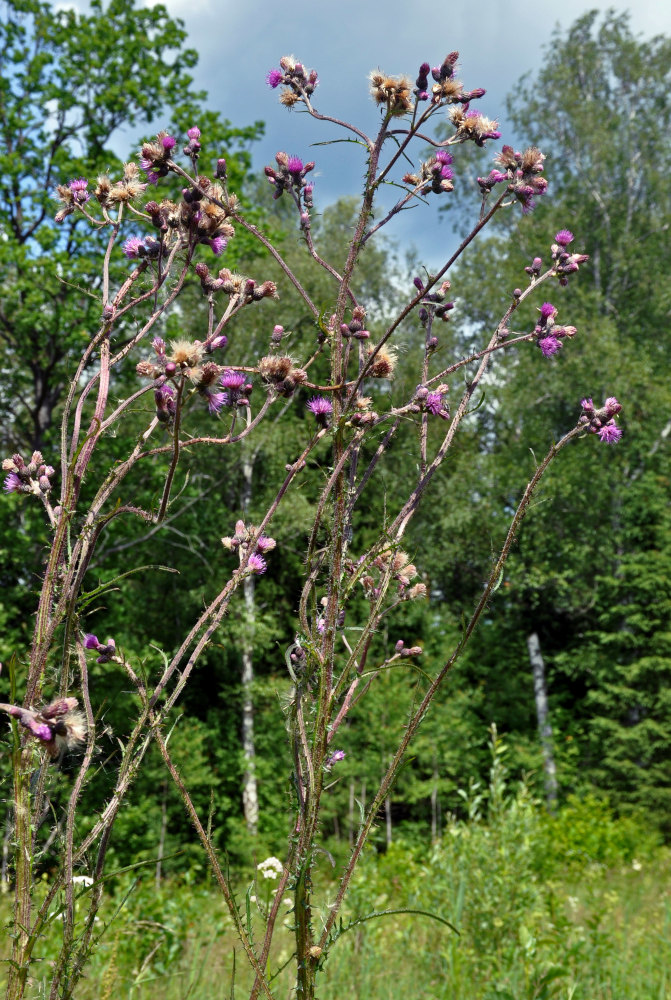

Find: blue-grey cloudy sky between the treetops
56;0;671;267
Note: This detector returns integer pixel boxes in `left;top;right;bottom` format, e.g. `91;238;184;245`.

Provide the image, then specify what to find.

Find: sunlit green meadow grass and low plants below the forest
0;783;671;1000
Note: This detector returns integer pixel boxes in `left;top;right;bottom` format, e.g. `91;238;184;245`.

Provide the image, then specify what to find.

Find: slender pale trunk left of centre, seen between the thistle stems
242;455;259;835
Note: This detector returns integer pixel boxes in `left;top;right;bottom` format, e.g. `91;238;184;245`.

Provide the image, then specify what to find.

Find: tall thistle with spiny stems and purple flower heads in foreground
0;52;621;1000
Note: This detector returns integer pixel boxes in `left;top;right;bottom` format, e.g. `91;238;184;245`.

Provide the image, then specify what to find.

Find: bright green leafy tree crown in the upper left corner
0;0;261;450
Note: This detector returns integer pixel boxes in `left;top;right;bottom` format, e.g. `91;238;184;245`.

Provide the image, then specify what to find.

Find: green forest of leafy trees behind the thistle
0;0;671;996
